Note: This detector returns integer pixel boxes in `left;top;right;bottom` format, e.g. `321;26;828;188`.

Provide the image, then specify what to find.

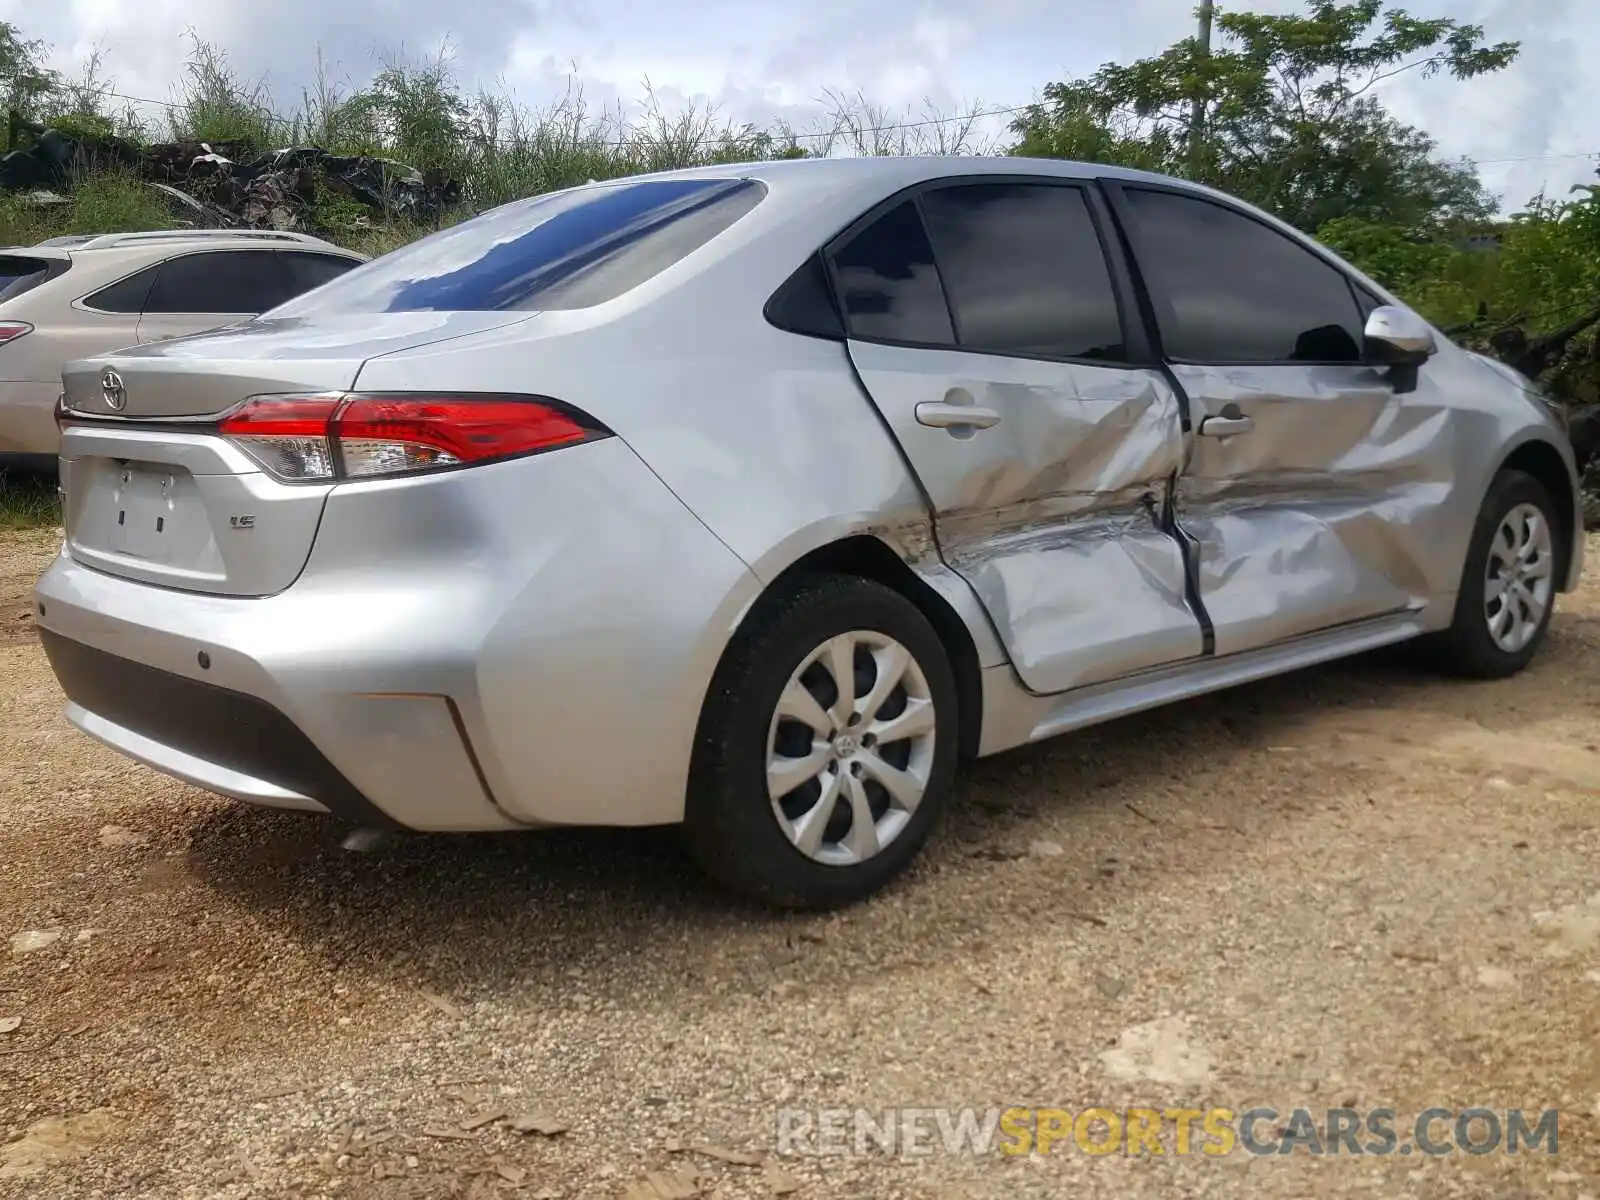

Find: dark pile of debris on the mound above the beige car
0;123;461;230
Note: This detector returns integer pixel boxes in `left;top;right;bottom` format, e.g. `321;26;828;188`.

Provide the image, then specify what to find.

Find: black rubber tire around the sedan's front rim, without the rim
1424;470;1566;680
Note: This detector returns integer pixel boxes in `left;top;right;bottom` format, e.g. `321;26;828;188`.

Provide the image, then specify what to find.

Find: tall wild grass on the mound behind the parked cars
0;24;1002;253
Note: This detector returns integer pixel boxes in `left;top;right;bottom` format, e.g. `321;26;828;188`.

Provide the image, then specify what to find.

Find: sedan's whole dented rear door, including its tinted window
827;176;1203;693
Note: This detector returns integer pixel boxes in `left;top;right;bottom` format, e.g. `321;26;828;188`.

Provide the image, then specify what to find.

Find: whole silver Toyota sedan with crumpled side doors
37;158;1582;907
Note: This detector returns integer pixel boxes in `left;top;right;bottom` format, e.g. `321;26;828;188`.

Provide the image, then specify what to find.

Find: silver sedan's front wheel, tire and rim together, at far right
1429;470;1562;678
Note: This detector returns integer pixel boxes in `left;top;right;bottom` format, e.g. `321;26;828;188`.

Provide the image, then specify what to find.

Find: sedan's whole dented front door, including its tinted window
1107;182;1453;654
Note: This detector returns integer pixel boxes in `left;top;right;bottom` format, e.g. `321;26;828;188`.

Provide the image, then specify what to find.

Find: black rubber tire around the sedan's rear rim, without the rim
683;574;960;909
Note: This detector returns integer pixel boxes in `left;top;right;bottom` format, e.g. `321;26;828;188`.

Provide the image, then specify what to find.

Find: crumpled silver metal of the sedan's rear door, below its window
850;342;1203;693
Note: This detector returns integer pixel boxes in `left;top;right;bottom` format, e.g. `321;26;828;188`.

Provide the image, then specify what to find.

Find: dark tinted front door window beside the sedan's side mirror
1125;189;1362;362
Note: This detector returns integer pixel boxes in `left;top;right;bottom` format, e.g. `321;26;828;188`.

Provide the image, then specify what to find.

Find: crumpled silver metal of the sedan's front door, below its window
1173;365;1461;654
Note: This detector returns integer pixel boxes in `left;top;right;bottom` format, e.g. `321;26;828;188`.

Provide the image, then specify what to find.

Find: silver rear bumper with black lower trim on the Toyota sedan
35;438;758;830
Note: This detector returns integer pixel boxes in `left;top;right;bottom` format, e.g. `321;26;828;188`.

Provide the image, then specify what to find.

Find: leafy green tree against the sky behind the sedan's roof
1013;0;1518;232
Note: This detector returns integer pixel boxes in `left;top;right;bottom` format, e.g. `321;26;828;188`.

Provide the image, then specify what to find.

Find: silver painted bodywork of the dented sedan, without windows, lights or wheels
38;158;1582;829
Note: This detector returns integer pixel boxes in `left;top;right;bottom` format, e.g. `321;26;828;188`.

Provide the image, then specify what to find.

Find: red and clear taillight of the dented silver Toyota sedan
221;392;611;483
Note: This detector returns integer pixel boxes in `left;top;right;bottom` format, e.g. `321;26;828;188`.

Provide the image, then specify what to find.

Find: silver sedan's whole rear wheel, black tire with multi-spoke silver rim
685;576;957;909
